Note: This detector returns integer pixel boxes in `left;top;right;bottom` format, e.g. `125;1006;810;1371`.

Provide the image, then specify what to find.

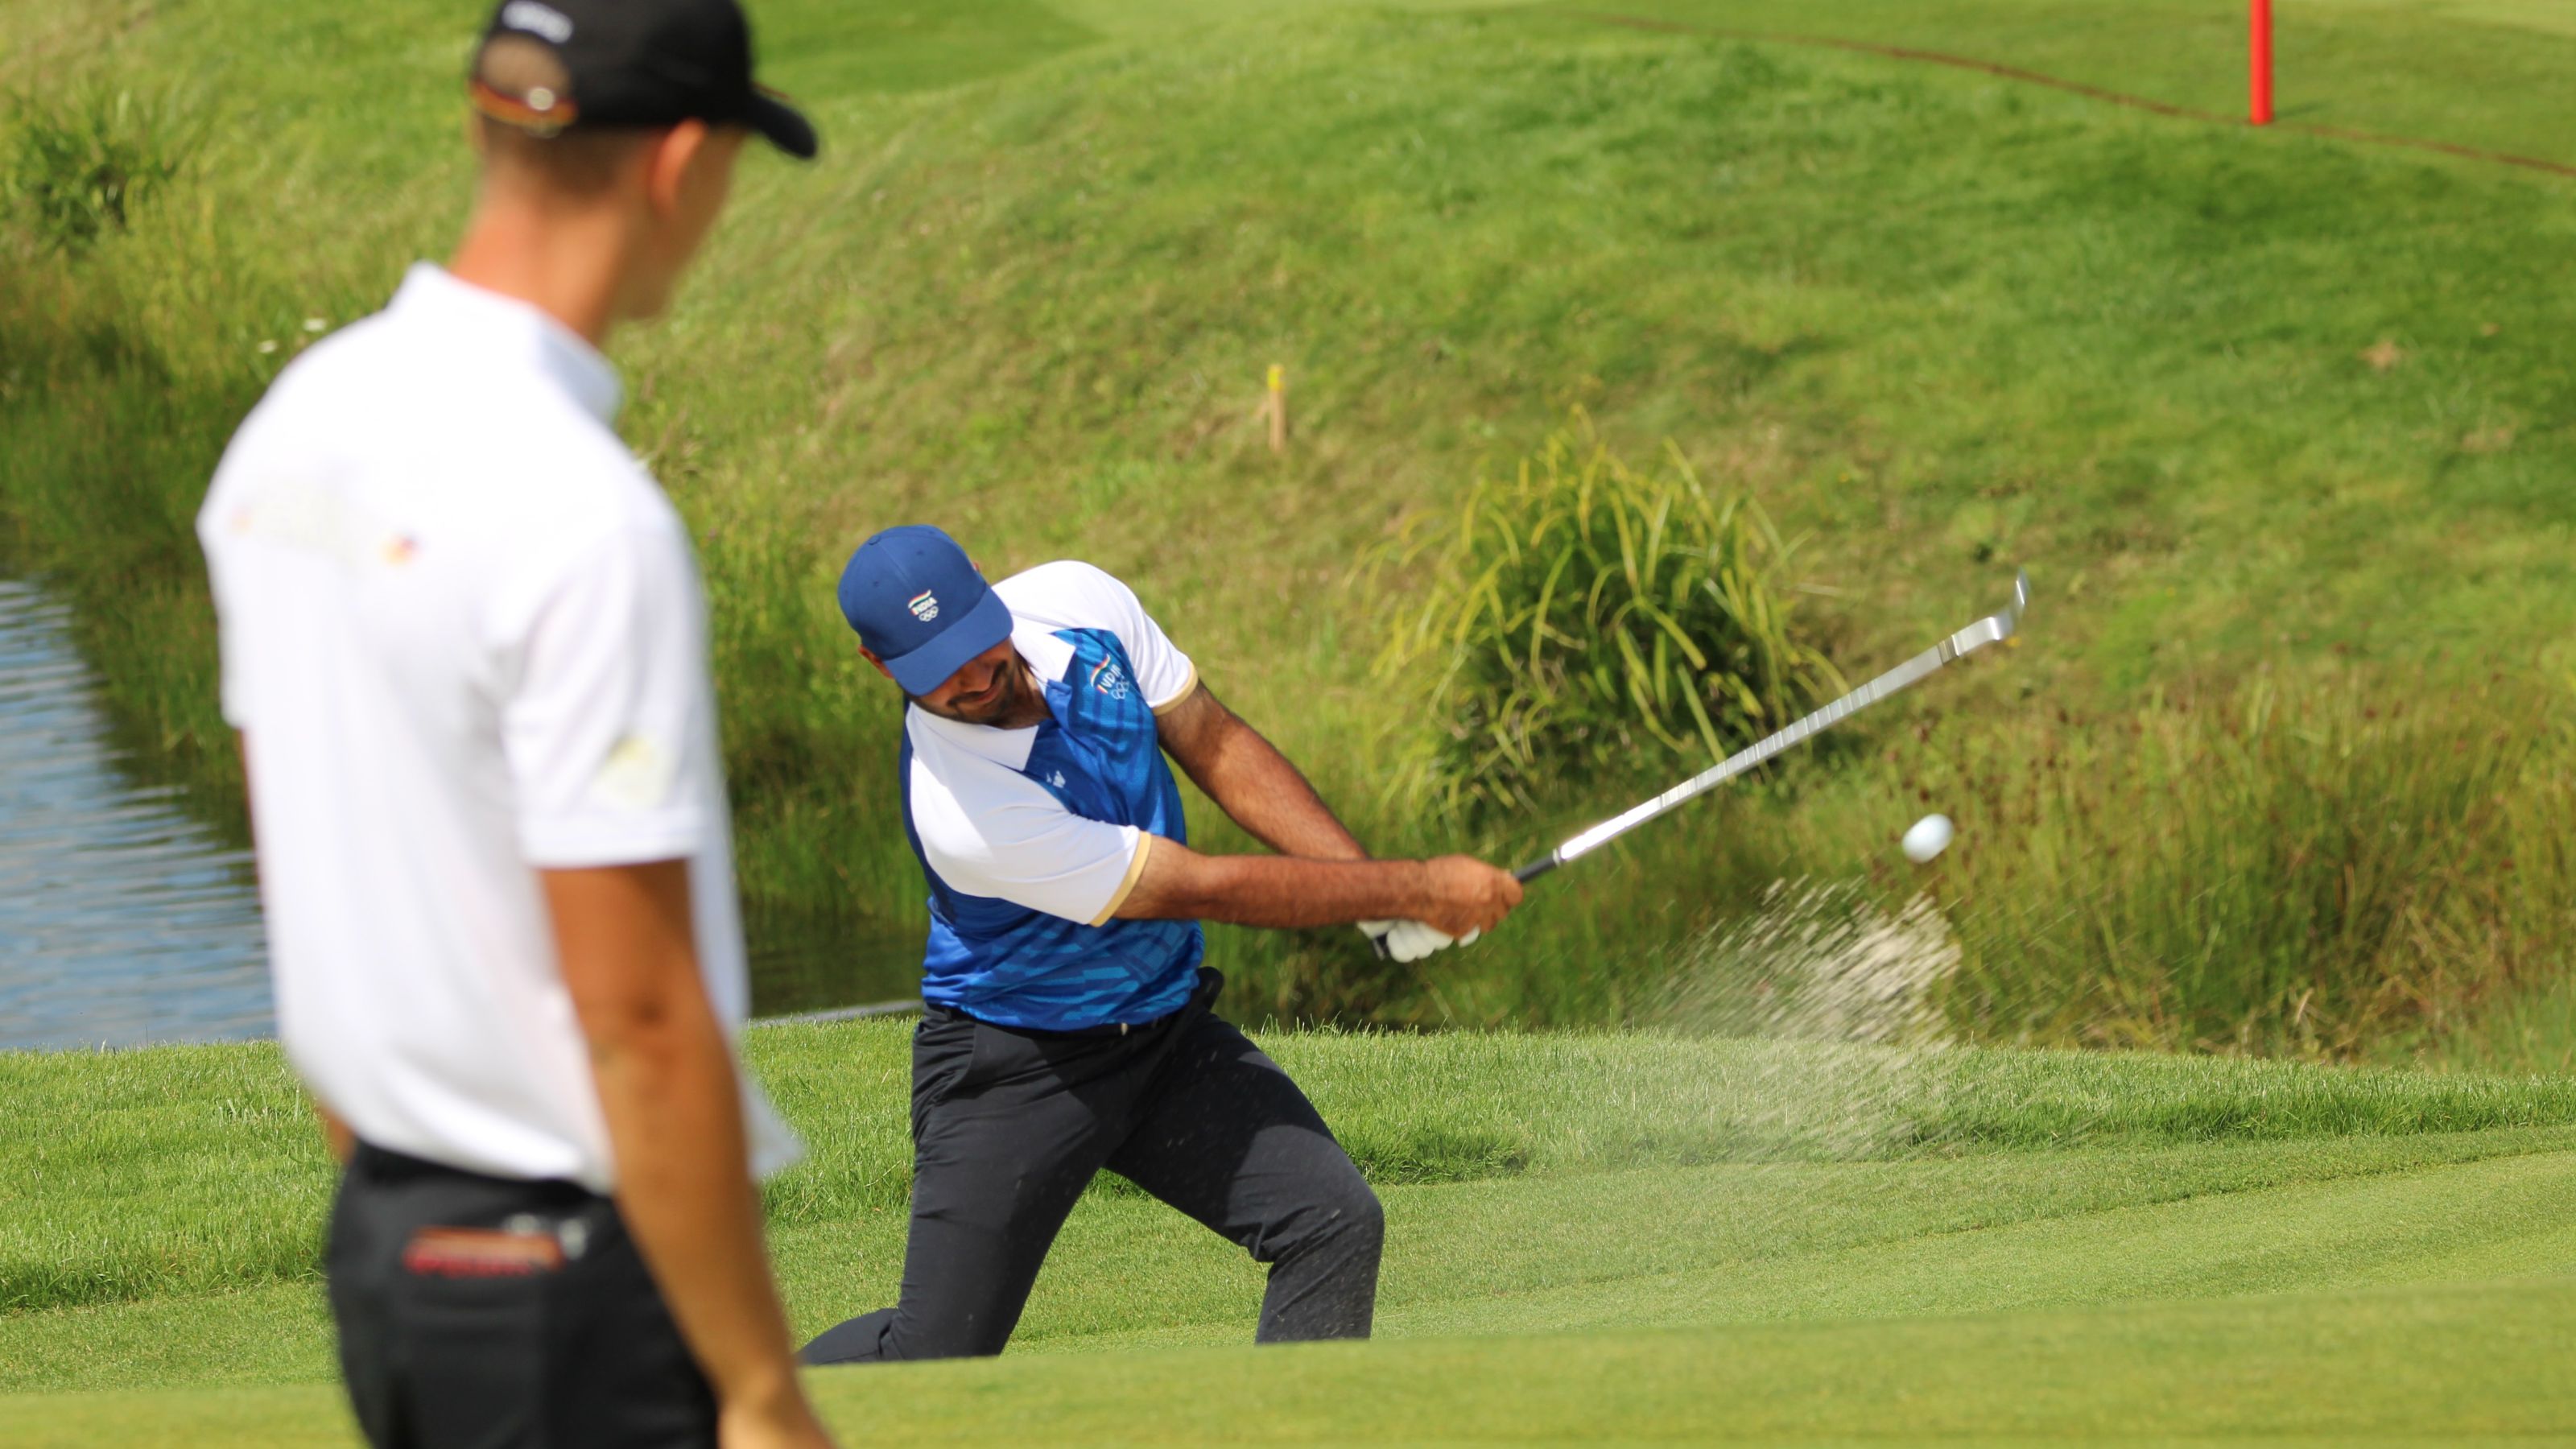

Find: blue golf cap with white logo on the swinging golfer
840;523;1009;694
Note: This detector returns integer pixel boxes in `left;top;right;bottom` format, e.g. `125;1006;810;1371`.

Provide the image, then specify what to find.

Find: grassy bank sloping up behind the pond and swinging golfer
0;0;2576;1055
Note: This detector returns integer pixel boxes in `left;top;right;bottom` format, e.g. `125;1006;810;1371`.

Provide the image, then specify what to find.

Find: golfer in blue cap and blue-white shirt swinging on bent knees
803;526;1520;1364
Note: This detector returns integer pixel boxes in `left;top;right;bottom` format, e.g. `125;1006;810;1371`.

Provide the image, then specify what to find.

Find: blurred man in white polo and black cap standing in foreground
198;0;824;1449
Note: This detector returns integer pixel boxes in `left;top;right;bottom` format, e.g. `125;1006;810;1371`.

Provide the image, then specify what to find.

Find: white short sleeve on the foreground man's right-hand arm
502;523;721;869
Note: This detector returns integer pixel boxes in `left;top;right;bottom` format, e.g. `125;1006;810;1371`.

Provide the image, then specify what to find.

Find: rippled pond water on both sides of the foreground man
0;580;923;1050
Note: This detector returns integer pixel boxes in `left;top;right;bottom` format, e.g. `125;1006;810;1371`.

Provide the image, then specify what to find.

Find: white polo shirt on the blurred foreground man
198;266;796;1191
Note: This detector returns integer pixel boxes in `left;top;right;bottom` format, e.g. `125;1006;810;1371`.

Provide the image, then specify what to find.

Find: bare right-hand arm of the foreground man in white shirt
543;861;796;1402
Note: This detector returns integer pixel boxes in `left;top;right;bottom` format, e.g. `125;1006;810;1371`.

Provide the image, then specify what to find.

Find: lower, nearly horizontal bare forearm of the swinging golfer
1118;838;1430;928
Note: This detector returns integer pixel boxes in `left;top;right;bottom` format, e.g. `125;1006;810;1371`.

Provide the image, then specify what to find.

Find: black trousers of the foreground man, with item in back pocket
327;1147;716;1449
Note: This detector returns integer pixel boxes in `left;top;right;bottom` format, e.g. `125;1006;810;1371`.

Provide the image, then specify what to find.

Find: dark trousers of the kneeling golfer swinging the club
803;972;1386;1364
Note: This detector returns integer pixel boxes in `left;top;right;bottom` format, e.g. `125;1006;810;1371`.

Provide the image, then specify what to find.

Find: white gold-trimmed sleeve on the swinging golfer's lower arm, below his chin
912;753;1154;926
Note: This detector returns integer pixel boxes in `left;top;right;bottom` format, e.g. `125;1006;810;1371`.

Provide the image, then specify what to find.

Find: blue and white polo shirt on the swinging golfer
902;562;1206;1031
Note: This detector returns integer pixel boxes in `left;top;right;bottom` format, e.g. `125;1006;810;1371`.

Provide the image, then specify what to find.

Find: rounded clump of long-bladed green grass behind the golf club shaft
1378;412;1839;817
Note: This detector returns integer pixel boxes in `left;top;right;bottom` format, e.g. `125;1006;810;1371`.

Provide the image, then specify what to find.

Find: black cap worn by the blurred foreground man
469;0;816;160
